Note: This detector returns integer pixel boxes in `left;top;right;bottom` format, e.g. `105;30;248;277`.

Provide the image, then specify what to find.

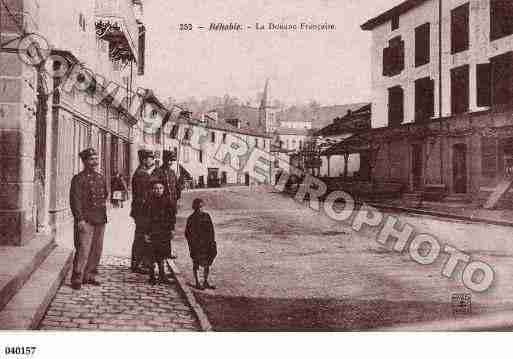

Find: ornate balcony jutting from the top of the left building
95;0;139;60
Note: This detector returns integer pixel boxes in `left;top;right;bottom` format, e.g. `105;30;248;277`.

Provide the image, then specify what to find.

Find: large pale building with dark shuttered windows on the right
362;0;513;205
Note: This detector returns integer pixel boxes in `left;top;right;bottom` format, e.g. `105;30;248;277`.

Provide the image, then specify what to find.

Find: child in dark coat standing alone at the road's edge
185;198;217;289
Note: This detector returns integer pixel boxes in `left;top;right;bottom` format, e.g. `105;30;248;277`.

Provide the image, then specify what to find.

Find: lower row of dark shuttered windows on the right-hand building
388;51;513;126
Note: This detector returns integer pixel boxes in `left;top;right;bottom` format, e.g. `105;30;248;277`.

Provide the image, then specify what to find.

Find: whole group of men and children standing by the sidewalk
70;148;217;290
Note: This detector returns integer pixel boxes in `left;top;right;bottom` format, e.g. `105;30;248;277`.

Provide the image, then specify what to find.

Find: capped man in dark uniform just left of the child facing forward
130;150;155;272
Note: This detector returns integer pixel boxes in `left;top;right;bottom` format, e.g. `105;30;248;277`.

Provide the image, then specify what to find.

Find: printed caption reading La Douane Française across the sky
179;22;337;31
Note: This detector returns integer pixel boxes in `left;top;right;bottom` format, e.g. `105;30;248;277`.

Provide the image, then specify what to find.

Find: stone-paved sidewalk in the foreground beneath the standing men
40;256;200;331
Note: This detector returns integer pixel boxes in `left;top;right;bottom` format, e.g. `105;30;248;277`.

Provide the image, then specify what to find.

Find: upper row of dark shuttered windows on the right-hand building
383;0;513;77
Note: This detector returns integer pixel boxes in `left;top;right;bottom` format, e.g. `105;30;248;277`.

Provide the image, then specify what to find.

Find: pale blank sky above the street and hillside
143;0;402;105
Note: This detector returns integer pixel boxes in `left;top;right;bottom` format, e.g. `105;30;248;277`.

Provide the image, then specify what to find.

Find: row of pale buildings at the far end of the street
143;91;272;187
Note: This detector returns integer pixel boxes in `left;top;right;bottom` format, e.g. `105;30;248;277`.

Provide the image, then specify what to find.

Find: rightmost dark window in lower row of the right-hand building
490;51;513;106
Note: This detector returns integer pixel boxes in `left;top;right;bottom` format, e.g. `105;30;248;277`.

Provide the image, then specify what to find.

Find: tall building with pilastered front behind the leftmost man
0;0;144;248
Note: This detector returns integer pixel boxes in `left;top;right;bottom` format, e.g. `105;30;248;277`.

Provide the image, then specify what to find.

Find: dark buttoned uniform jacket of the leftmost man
70;171;108;225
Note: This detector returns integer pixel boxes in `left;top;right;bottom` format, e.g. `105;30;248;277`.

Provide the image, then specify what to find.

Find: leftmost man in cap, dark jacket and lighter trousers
70;148;108;290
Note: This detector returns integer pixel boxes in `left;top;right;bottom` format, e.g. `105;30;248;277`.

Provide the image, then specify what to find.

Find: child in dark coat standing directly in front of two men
143;178;176;285
